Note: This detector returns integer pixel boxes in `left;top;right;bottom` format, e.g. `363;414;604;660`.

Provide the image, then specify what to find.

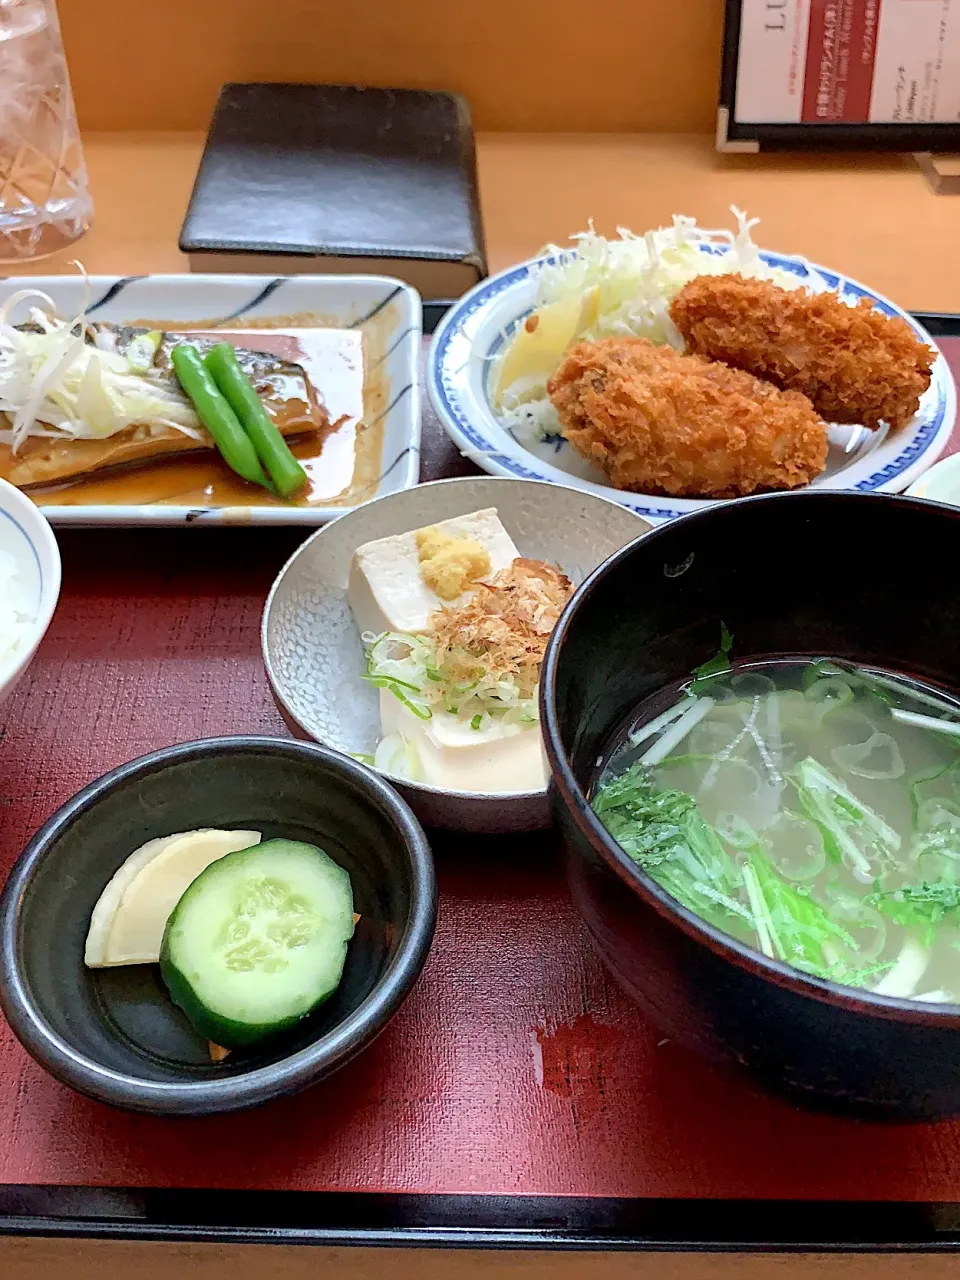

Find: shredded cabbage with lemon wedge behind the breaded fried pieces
498;207;828;444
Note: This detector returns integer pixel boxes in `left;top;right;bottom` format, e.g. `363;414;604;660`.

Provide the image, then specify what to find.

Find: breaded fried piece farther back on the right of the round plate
669;275;936;429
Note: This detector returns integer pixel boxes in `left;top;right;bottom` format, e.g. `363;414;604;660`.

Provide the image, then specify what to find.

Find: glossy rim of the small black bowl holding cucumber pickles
0;735;436;1115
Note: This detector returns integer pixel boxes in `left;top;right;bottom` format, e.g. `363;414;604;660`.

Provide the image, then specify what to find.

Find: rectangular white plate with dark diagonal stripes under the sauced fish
0;274;421;525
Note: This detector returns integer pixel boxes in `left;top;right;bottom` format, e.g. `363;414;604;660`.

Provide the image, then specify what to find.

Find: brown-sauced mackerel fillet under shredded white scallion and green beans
0;324;332;489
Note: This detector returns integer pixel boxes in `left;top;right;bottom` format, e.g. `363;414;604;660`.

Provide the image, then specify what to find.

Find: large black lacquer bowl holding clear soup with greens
540;493;960;1120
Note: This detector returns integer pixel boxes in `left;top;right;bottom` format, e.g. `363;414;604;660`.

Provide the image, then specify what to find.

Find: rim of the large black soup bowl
540;489;960;1025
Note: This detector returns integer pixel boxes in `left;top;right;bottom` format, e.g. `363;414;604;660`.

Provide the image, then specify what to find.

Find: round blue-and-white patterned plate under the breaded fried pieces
428;250;956;521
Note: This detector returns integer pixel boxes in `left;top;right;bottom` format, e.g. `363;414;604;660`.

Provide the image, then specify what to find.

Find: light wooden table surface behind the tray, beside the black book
13;133;960;311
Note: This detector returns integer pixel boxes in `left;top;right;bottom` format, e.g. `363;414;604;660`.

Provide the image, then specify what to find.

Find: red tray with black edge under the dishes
0;327;960;1247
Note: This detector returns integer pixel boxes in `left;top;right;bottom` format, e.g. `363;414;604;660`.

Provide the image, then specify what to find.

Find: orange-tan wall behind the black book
59;0;723;132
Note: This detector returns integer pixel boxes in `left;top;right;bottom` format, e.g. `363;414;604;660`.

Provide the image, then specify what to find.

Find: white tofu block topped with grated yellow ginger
347;507;520;634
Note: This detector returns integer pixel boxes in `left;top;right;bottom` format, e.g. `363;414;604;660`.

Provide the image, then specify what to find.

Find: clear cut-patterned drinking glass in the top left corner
0;0;93;262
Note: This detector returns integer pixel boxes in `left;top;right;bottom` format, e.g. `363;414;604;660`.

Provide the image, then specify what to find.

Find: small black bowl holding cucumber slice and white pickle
0;737;436;1115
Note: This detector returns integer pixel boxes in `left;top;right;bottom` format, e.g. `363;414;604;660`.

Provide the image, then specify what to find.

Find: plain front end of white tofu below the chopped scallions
380;689;547;795
